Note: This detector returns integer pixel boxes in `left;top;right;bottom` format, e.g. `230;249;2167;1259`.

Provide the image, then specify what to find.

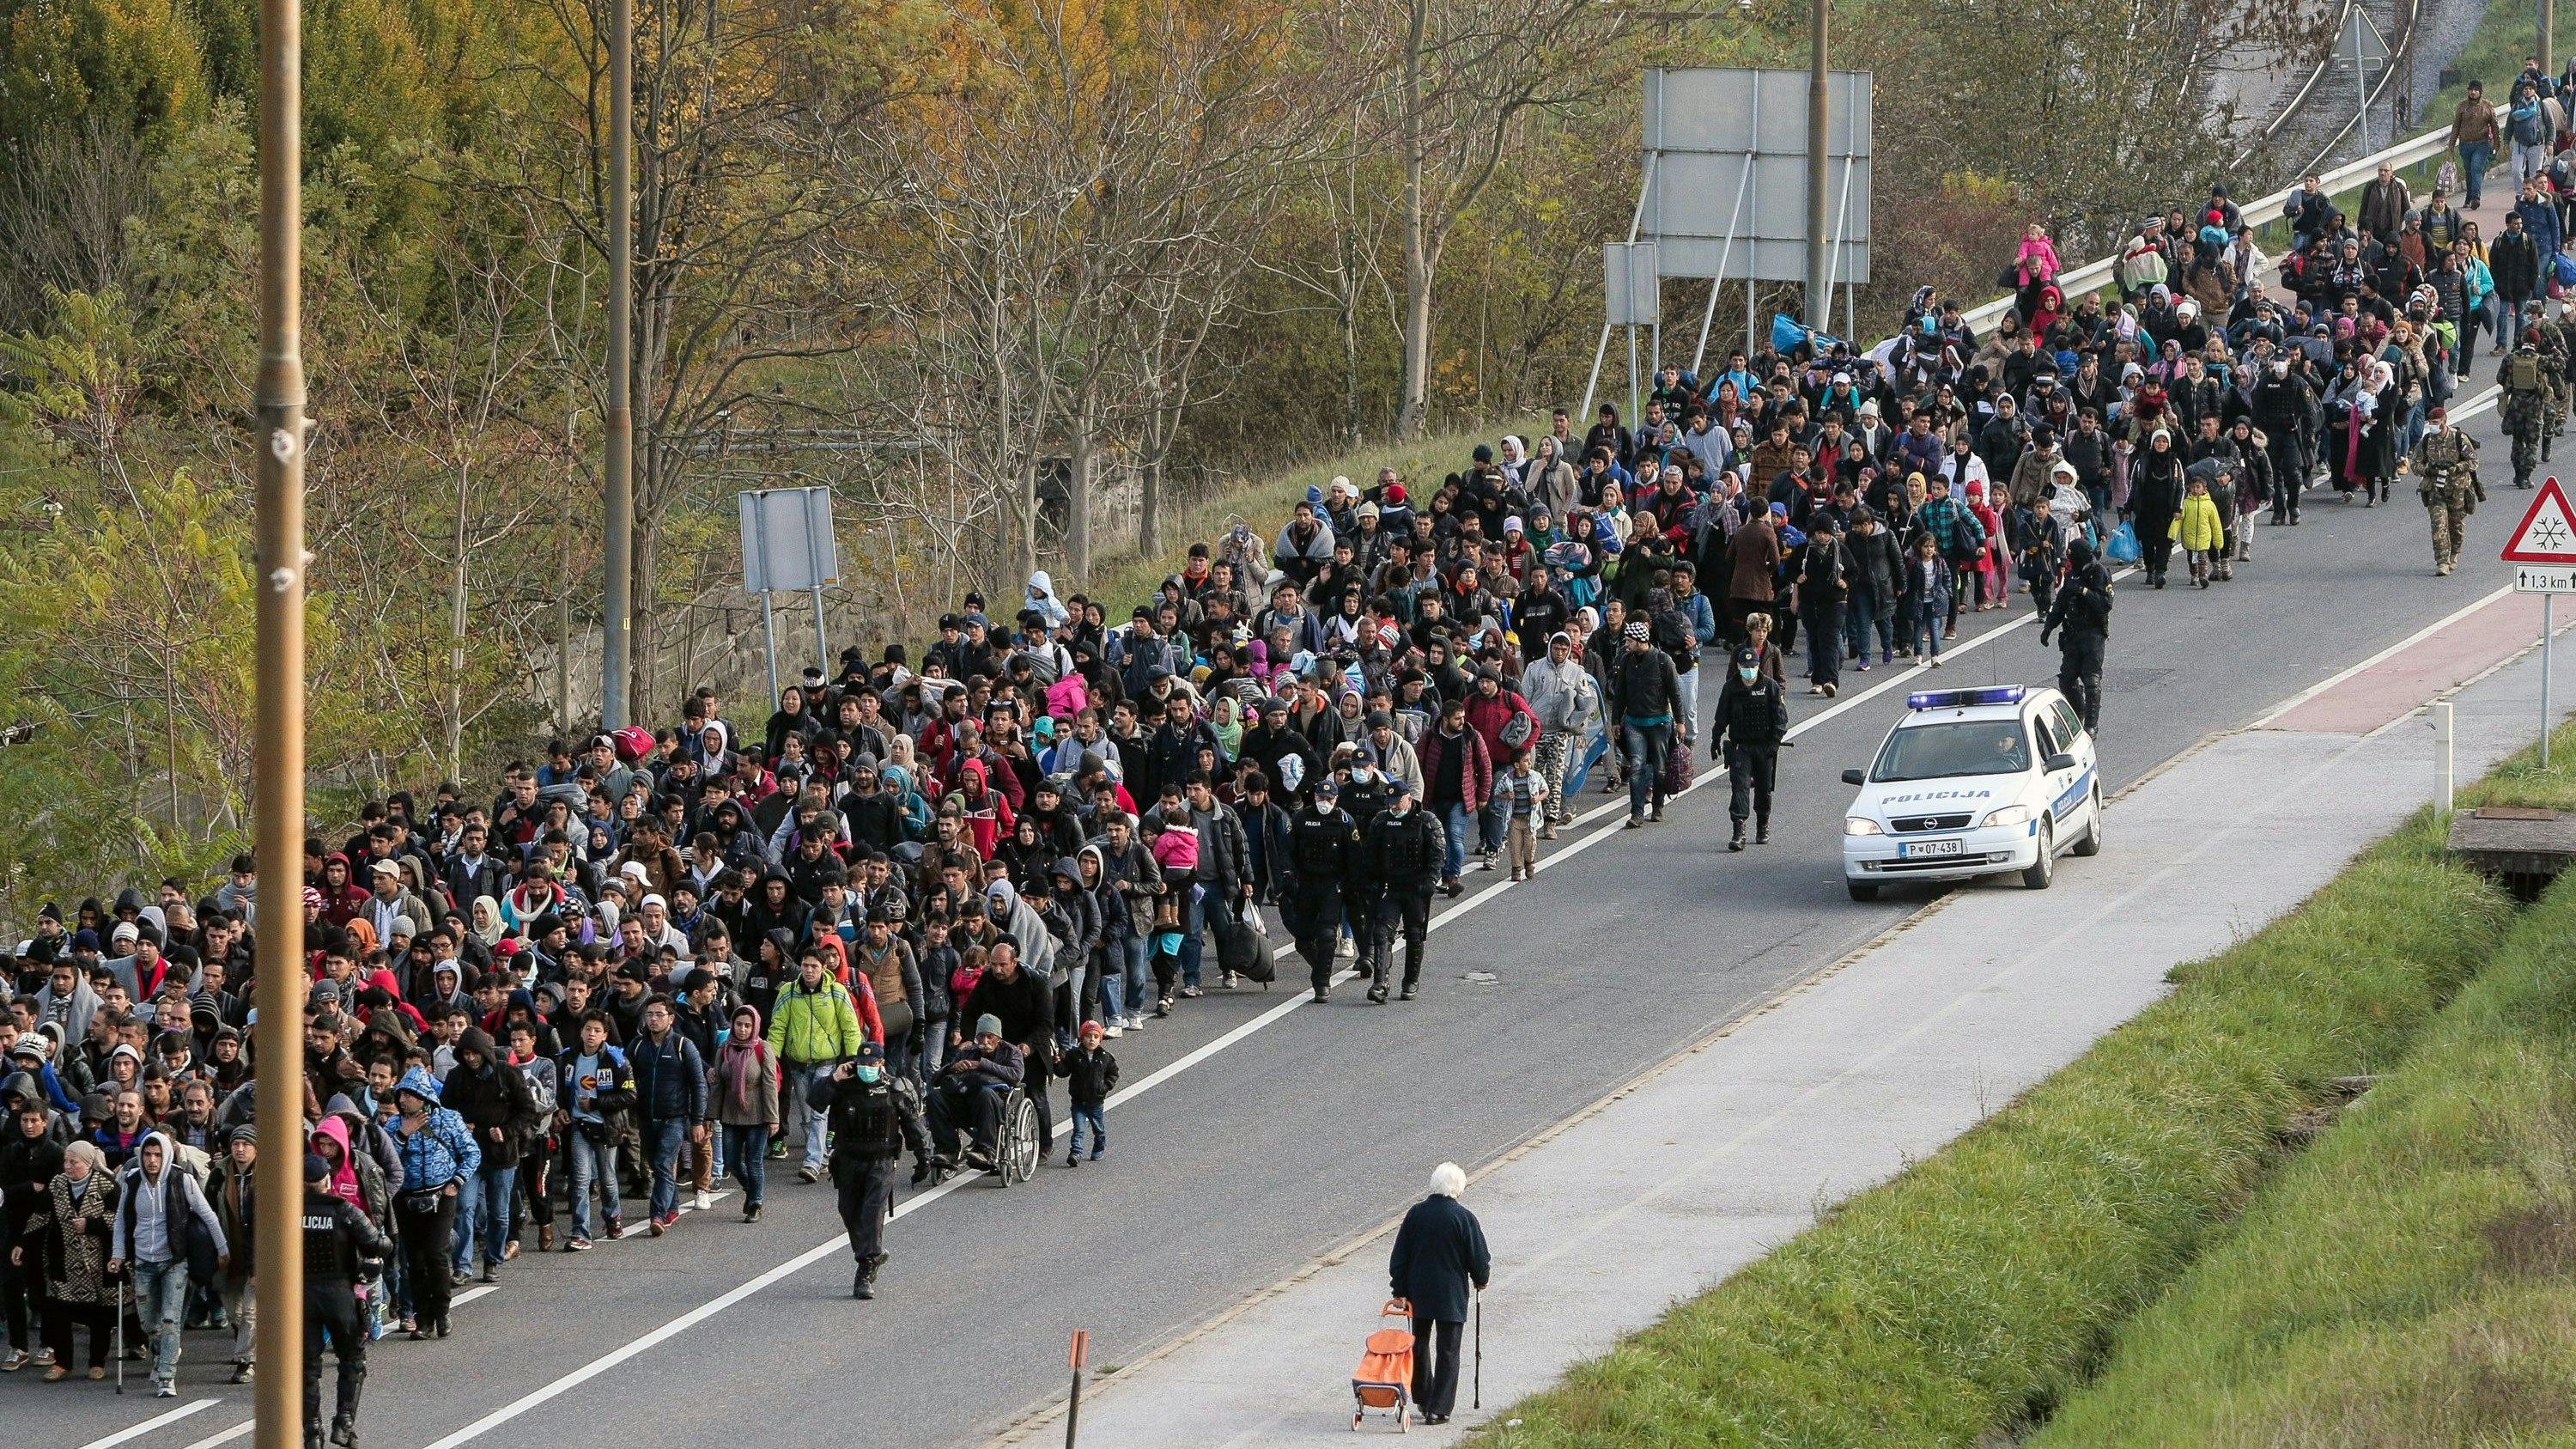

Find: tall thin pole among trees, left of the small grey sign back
600;0;636;730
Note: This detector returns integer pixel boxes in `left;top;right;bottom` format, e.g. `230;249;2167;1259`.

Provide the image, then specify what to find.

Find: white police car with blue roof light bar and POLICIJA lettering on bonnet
1842;683;2102;900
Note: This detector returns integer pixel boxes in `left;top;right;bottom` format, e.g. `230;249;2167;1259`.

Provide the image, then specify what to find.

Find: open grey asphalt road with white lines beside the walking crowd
20;384;2522;1449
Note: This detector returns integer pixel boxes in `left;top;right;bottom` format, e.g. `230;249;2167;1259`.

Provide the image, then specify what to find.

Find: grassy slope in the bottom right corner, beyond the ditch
2030;855;2576;1449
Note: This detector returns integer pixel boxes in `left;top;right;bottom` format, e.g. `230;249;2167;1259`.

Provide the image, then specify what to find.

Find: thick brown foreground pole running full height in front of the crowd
252;0;304;1449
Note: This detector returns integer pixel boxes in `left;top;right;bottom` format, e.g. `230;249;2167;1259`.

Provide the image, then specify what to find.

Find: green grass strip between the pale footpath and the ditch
1504;815;2509;1449
